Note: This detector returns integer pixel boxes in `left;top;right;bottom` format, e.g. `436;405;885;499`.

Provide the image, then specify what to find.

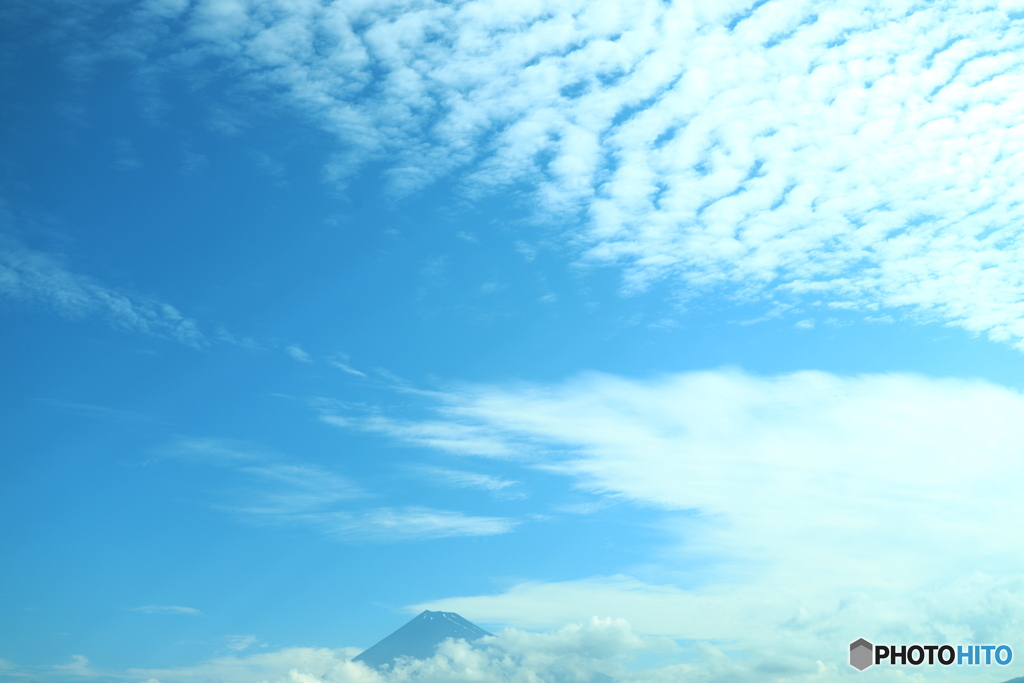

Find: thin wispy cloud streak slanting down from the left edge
0;232;208;348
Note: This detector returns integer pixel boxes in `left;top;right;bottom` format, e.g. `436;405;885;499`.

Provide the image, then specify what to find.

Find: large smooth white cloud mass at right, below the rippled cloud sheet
323;370;1024;666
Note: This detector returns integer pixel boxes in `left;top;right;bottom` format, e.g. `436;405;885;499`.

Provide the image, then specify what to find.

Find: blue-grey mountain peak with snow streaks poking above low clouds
352;609;493;669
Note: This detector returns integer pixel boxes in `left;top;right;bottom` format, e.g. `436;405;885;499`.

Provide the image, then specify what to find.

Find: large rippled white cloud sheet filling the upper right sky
110;0;1024;345
